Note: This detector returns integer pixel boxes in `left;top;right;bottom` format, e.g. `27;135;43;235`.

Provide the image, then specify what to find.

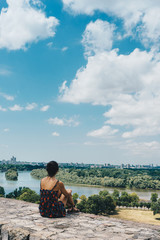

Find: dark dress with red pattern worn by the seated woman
39;181;66;218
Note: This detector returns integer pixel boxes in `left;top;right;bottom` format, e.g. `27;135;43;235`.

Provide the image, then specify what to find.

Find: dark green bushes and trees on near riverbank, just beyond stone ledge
0;187;160;215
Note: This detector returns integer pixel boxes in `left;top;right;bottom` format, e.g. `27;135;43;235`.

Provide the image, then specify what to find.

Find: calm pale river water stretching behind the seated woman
0;171;160;200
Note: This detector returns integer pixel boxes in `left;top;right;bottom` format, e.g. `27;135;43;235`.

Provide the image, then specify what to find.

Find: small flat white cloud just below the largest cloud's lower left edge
87;126;118;138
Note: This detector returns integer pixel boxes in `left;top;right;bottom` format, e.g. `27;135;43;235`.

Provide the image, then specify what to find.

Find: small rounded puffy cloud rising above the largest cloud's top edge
82;19;115;56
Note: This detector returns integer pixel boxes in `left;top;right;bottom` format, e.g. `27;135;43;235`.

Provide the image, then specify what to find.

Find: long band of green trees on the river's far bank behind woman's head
31;168;160;190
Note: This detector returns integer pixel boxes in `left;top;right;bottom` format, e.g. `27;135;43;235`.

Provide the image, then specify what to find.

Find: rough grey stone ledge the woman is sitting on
0;198;160;240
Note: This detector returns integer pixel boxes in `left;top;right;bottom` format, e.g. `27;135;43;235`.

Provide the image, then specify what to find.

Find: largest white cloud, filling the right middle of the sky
59;24;160;139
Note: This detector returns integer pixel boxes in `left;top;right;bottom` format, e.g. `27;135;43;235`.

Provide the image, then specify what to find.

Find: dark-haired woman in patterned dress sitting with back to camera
39;161;78;218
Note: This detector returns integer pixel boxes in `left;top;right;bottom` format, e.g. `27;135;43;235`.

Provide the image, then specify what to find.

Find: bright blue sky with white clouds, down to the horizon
0;0;160;164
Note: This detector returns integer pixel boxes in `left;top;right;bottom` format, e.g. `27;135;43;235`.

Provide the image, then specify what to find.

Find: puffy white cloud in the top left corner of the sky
0;0;58;50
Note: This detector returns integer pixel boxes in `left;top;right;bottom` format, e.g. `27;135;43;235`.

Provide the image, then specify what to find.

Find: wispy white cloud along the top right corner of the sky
63;0;160;45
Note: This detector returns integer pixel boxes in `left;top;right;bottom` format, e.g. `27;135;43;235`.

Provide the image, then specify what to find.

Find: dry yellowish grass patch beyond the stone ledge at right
112;209;160;226
